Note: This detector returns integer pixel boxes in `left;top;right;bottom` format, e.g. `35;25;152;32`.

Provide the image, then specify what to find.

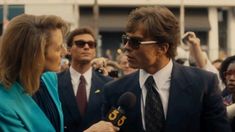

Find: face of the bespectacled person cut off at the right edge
225;62;235;93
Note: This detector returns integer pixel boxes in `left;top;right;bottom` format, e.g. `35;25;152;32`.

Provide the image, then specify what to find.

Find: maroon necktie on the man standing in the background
76;75;87;116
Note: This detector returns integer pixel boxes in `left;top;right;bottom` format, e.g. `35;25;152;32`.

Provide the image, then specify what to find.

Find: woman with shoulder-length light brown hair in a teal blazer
0;14;68;132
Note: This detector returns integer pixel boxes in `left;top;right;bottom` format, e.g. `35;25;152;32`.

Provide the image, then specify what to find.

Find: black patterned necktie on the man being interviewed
144;76;165;132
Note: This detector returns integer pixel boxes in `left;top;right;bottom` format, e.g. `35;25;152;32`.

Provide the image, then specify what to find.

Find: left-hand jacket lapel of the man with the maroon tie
61;70;81;120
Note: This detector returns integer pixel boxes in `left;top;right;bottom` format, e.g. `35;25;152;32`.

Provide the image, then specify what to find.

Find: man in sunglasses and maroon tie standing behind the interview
58;28;111;132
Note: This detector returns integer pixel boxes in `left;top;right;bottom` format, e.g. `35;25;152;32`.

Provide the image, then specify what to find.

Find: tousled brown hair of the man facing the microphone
126;6;179;58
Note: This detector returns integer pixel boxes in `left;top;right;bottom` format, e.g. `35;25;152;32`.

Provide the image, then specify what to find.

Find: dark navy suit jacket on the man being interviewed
103;63;231;132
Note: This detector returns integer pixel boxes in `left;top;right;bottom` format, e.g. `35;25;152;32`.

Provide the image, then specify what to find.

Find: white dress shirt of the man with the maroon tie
69;66;92;101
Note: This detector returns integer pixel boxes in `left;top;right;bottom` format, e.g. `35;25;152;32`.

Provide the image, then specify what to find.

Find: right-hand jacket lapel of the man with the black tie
166;63;193;131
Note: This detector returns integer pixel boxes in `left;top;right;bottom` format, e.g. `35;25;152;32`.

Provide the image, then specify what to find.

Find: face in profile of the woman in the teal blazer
45;29;66;71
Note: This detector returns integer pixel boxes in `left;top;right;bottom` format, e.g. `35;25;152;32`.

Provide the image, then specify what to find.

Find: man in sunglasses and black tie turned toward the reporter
103;6;231;132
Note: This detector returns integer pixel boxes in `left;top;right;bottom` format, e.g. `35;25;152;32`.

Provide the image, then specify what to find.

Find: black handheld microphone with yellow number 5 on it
106;92;136;127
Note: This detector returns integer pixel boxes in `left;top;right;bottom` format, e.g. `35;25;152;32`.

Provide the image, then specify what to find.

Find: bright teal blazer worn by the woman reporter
0;72;64;132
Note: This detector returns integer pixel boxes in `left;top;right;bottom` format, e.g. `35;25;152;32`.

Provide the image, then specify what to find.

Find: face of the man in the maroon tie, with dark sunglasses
70;34;96;64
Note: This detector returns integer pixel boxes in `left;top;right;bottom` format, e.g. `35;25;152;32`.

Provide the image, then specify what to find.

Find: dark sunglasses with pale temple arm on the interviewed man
122;34;157;49
